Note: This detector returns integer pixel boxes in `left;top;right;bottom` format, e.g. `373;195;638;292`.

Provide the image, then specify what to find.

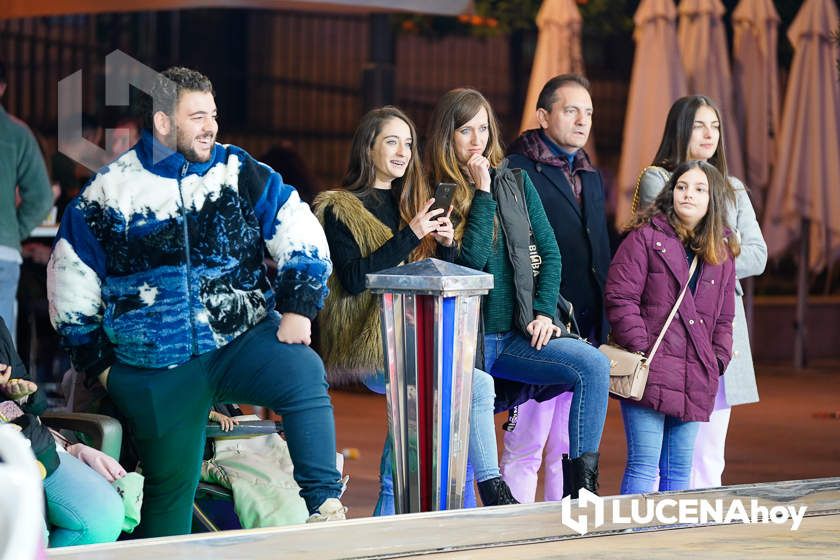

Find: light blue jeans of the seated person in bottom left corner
44;453;125;547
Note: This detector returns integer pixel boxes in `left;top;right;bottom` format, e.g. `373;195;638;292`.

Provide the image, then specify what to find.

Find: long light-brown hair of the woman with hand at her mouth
424;88;504;241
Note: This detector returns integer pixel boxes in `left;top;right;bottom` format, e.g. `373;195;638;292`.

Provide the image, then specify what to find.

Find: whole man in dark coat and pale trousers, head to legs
496;74;610;503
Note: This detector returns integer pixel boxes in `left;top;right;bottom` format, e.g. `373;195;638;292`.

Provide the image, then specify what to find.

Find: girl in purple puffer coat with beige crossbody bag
605;161;739;494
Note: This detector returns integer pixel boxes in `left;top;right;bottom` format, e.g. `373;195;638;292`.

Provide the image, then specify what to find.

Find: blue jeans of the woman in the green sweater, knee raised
484;331;610;459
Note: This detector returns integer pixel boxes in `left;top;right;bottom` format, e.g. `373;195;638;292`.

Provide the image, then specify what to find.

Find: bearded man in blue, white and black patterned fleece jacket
48;67;345;537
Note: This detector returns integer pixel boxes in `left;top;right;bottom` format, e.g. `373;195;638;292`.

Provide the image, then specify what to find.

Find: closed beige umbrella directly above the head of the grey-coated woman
677;0;744;179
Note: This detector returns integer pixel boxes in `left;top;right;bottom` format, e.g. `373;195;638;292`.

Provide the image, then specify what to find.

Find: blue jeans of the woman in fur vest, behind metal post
364;369;501;516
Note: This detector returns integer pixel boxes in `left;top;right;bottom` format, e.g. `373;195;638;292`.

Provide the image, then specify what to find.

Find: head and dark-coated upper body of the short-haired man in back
508;74;610;345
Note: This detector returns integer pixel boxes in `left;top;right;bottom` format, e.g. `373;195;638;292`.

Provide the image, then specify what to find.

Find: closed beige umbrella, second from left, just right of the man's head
616;0;686;226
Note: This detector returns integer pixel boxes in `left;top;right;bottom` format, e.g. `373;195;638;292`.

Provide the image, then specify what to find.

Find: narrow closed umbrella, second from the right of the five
732;0;779;214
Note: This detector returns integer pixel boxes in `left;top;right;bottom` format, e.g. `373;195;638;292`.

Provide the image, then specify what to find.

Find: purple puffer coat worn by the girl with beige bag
605;215;735;422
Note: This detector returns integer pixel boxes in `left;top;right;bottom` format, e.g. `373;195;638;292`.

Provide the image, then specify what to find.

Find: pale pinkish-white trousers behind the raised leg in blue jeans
499;392;574;504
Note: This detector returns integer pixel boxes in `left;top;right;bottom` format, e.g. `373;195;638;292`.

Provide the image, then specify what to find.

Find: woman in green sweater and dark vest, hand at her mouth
426;89;610;498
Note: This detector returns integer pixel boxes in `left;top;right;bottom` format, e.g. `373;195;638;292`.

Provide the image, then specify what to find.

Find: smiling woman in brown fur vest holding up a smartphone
315;106;516;515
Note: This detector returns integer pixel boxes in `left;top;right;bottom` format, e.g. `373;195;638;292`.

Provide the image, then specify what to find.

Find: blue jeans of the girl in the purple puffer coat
621;401;700;494
